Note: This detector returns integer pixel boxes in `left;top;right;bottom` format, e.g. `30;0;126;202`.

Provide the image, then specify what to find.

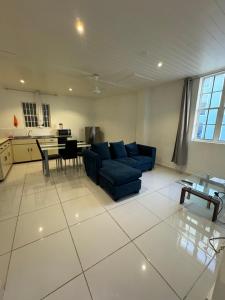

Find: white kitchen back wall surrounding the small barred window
0;89;94;139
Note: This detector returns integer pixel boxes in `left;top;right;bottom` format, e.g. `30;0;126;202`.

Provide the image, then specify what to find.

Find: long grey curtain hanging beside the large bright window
172;78;192;166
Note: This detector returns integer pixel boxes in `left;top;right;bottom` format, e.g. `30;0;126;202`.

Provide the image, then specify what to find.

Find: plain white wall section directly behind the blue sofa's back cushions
95;93;137;142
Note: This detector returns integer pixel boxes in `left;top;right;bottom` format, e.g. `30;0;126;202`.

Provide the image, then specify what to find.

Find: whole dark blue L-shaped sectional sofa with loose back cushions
84;141;156;200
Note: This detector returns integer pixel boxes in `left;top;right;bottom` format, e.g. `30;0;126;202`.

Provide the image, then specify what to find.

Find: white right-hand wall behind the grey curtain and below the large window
141;80;225;178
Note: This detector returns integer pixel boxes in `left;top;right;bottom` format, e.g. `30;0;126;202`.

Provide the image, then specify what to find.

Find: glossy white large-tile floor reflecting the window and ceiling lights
0;162;225;300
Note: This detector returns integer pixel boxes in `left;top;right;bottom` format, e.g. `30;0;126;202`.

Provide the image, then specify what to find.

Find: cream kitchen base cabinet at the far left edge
0;141;13;180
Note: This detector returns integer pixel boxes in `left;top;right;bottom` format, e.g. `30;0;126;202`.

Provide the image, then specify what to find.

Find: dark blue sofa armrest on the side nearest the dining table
84;150;102;184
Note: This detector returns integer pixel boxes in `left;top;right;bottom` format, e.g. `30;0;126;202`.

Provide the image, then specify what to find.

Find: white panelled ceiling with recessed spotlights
0;0;225;96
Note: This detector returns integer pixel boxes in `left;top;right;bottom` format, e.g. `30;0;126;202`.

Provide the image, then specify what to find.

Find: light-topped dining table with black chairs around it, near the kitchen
40;142;91;177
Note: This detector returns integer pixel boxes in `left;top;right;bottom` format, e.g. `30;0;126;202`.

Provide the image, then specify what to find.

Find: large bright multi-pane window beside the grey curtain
194;73;225;142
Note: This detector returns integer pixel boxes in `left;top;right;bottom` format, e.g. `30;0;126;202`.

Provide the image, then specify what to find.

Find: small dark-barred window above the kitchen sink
22;102;51;127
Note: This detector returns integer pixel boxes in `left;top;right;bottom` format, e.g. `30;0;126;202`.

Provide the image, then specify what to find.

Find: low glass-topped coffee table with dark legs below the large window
179;173;225;222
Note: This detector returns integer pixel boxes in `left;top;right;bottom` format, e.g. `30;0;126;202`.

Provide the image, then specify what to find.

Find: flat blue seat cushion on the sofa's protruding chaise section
99;164;141;185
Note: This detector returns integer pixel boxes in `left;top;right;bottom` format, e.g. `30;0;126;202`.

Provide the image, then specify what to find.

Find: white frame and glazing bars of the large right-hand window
192;71;225;144
